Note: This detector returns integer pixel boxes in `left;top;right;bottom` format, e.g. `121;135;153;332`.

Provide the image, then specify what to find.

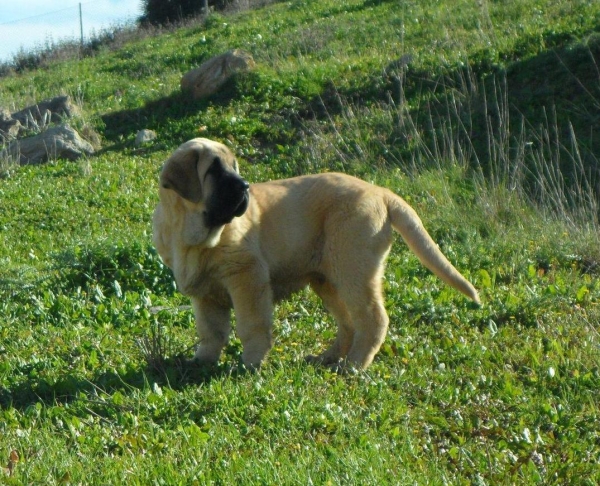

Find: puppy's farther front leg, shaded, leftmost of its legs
192;297;231;364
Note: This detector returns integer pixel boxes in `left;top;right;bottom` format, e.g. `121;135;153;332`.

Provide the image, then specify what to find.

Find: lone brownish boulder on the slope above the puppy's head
181;49;256;100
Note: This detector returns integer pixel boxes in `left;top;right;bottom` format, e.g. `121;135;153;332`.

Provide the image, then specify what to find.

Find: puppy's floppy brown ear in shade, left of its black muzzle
160;150;202;203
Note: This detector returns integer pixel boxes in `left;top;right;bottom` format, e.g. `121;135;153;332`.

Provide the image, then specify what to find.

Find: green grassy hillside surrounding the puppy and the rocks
0;0;600;485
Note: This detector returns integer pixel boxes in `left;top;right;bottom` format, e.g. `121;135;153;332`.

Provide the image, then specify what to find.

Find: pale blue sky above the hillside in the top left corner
0;0;142;62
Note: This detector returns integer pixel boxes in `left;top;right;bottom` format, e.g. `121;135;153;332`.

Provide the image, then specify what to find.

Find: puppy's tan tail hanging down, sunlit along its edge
387;194;481;304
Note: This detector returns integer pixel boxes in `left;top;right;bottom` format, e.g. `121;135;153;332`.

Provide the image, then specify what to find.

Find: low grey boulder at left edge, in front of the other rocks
0;125;94;165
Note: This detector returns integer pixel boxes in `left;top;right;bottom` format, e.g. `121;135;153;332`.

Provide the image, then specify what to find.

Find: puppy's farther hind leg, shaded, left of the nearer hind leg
306;280;354;365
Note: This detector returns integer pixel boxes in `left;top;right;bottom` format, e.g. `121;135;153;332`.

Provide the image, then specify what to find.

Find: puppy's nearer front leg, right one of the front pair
230;274;273;369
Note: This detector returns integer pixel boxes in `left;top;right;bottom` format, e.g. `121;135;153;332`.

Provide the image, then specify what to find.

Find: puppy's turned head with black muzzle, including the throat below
160;138;250;246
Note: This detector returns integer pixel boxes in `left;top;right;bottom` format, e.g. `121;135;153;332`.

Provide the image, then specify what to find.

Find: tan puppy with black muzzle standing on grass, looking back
153;138;479;368
